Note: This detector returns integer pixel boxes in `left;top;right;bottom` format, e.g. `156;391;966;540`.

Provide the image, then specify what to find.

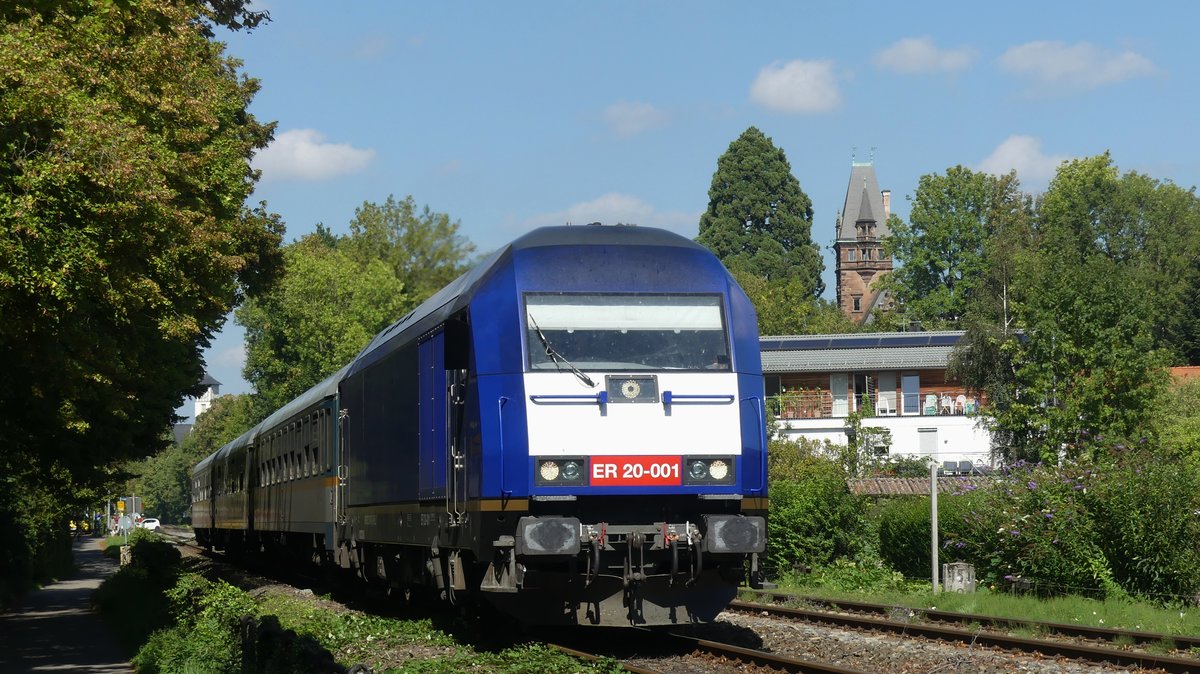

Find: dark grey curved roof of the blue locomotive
346;224;707;377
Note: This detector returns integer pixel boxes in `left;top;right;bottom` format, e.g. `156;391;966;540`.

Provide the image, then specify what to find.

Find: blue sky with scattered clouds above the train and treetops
179;0;1200;416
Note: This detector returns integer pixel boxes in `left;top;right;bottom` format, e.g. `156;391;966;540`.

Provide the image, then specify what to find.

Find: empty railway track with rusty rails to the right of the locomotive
728;595;1200;673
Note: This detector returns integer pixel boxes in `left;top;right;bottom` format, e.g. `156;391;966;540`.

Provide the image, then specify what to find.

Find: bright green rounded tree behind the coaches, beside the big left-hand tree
235;235;410;416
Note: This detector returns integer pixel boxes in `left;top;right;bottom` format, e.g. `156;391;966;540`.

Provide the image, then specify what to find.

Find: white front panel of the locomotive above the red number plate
524;372;742;456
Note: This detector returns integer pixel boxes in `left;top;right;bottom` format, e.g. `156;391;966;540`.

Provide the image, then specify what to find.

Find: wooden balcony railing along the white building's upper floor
768;389;983;419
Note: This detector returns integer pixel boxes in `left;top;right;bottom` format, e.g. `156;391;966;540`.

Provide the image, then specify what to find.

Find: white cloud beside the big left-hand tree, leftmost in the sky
253;128;376;182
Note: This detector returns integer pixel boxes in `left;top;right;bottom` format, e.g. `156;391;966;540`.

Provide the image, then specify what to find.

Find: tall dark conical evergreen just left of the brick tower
696;126;824;293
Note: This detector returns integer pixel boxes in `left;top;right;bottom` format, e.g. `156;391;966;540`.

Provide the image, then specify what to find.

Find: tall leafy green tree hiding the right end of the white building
966;155;1166;461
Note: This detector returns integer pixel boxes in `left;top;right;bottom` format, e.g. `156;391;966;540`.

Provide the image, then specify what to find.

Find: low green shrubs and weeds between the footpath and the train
96;535;622;674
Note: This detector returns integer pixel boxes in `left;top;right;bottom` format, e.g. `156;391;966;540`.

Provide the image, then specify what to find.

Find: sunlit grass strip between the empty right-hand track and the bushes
763;568;1200;636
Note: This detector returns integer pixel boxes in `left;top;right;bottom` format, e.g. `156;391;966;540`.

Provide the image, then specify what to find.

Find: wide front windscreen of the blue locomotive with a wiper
526;294;730;371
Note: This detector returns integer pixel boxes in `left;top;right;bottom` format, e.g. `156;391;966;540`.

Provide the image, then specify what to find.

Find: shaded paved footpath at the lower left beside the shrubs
0;538;133;674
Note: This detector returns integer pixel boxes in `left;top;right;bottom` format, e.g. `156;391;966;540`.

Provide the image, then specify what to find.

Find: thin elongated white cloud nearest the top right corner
1000;41;1158;89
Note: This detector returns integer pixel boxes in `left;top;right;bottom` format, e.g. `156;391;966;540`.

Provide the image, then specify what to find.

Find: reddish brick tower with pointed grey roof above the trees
833;162;892;324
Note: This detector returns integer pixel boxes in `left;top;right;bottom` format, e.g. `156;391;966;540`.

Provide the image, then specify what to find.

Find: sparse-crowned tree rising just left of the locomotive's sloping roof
340;195;475;311
